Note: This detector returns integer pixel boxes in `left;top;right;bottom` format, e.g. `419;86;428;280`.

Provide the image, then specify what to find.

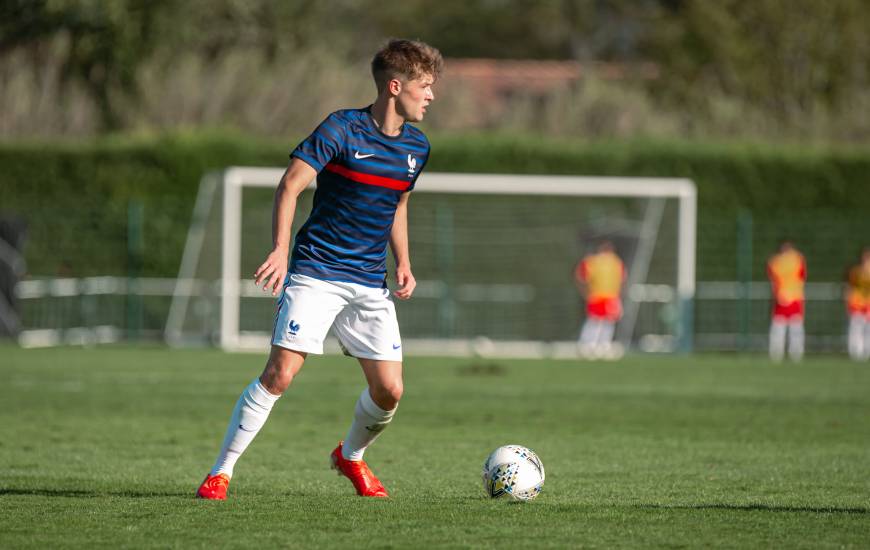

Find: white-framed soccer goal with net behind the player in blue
166;167;696;357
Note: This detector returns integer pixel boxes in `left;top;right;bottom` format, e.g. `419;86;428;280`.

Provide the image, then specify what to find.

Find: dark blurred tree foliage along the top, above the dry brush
0;0;870;139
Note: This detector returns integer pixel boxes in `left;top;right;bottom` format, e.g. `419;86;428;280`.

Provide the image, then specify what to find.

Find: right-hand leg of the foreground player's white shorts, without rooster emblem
333;288;402;363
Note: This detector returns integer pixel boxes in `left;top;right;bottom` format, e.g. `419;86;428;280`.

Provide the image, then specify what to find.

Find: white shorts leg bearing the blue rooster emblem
272;274;349;354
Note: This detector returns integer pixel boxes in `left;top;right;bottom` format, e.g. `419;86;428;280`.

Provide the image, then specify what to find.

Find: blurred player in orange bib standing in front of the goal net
574;240;626;357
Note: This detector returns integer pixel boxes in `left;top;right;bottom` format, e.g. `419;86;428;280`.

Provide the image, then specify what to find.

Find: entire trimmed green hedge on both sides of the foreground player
0;135;870;276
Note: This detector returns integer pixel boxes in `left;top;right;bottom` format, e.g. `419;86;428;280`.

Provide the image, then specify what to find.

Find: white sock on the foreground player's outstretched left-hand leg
211;378;280;477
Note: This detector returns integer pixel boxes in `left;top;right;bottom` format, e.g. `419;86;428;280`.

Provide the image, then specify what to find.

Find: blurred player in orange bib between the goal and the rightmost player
767;240;807;361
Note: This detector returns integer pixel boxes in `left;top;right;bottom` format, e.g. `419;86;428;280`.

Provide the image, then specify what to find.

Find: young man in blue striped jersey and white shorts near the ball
197;40;442;500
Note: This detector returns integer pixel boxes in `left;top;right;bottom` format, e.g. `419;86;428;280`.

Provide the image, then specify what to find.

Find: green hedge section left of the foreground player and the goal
0;136;287;276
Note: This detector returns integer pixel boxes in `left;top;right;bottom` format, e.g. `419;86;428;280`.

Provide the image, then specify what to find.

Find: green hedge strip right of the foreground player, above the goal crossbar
428;136;870;212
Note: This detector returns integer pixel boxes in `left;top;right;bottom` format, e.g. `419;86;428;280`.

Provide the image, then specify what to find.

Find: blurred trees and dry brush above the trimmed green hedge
0;0;870;143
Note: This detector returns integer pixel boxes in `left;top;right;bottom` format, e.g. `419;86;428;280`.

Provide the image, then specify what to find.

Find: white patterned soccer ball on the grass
483;445;544;500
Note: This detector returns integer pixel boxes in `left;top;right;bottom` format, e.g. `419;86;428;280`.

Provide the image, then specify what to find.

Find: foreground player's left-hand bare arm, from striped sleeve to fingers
254;158;317;296
